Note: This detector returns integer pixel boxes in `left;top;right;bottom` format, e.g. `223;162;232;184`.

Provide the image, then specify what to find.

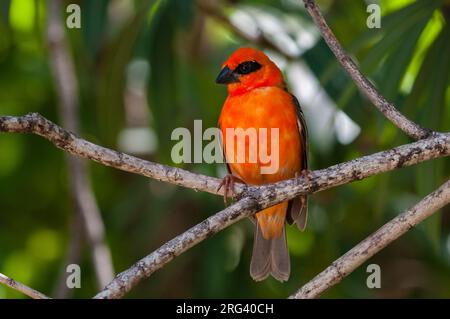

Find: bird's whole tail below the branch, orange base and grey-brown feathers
250;203;291;282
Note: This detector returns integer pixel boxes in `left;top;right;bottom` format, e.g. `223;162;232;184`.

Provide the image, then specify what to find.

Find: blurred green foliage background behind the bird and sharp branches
0;0;450;298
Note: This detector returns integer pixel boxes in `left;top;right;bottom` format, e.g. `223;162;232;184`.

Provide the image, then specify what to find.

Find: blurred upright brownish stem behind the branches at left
47;0;114;289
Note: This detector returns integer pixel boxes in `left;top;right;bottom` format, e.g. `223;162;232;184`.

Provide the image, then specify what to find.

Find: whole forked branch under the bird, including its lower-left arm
0;113;450;298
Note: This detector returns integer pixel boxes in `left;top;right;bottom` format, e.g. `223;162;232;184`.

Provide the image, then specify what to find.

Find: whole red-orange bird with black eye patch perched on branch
216;48;308;281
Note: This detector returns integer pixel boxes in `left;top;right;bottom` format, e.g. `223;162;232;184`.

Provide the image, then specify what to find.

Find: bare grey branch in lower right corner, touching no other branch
290;180;450;299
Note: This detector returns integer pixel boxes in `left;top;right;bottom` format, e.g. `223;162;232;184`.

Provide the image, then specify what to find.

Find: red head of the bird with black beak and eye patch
216;48;285;94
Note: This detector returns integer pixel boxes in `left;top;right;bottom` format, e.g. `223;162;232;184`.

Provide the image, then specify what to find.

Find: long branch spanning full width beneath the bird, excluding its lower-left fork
0;113;450;206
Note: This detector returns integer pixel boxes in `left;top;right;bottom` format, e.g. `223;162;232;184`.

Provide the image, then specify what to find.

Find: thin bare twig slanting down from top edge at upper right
303;0;432;139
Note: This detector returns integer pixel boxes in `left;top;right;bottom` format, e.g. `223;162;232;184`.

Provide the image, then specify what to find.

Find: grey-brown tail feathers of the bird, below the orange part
250;223;291;282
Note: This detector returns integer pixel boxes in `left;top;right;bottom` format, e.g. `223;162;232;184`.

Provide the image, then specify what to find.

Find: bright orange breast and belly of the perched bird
219;87;301;184
